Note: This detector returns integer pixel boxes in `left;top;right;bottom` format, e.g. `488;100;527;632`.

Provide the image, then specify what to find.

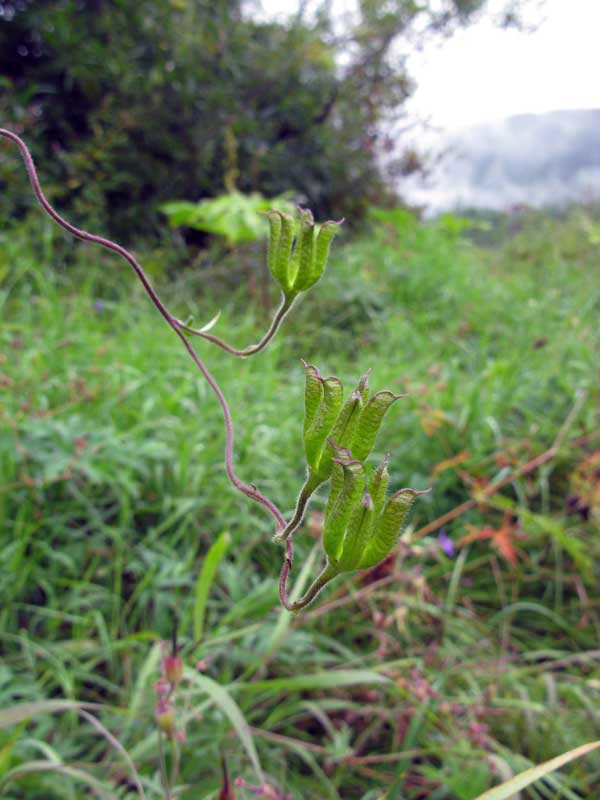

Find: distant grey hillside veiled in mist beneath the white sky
408;109;600;216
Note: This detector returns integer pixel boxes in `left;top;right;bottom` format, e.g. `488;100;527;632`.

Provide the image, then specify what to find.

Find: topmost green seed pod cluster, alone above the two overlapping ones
266;209;341;300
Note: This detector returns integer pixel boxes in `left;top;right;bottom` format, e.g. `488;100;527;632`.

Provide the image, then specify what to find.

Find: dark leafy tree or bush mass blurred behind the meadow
0;0;536;239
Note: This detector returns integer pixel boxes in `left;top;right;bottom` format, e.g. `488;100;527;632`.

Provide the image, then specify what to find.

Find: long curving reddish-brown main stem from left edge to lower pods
0;128;285;531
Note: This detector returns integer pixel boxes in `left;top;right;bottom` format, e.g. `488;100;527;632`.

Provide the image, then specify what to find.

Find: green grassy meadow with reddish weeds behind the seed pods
0;209;600;800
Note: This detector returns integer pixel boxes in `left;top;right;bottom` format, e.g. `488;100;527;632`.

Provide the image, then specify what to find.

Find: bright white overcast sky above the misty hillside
255;0;600;130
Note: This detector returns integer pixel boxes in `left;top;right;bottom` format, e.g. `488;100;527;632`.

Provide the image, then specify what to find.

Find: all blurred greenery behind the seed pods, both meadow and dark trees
0;0;600;800
